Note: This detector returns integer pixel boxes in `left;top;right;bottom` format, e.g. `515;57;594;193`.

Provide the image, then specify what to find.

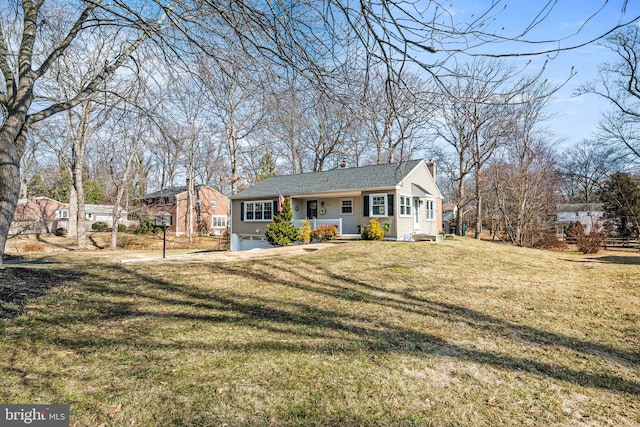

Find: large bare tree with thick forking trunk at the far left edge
0;0;164;267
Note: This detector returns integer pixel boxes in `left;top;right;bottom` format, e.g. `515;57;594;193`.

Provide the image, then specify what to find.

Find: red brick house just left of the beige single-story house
142;184;229;236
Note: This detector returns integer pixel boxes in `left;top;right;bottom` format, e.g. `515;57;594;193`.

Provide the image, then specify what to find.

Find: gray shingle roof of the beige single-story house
231;160;422;199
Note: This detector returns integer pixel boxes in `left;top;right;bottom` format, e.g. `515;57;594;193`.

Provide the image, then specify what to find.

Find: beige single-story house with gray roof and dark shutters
231;160;442;250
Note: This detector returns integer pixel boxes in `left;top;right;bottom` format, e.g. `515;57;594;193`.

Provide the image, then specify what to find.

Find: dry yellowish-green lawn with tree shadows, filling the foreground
0;239;640;426
